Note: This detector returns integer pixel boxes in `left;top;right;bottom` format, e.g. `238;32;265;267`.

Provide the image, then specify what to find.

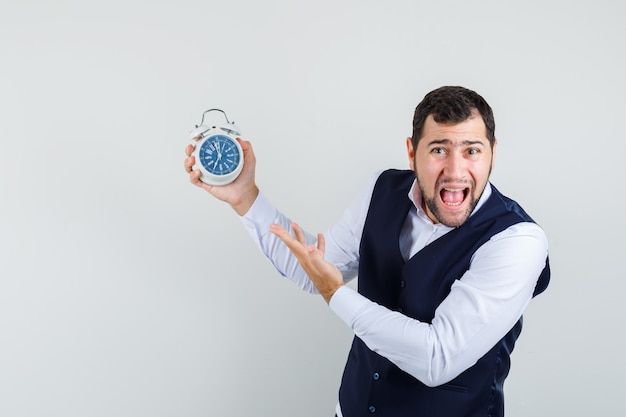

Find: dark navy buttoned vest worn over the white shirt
339;170;550;417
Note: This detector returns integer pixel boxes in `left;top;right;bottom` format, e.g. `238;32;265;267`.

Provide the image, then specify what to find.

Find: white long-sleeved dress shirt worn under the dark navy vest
241;172;548;416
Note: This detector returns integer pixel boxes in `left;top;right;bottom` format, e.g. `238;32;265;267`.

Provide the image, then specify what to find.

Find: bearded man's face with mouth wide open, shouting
407;112;496;227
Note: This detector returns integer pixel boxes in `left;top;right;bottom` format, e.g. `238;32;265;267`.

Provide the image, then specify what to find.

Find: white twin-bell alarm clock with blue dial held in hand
189;109;243;186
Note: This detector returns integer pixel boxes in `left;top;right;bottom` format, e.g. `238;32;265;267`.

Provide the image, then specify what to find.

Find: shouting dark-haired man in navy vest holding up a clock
184;87;550;417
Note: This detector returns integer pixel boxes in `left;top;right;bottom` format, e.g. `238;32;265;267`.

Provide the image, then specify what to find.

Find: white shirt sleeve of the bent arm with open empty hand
330;223;548;386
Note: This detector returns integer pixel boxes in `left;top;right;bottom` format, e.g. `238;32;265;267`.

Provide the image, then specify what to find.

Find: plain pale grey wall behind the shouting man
0;0;626;417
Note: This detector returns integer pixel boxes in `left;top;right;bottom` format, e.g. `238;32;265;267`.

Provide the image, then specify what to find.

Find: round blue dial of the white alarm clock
198;135;241;175
